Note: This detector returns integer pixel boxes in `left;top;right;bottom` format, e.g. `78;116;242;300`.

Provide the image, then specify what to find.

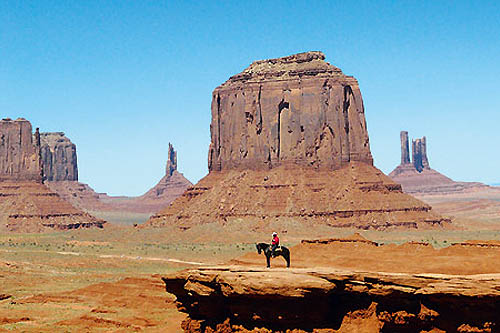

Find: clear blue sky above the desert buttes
0;0;500;195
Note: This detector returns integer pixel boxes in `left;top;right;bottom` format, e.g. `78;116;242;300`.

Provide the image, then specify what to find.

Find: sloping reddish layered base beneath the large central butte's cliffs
149;162;449;232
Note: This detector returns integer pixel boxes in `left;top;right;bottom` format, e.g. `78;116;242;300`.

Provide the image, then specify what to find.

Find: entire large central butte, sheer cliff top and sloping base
146;52;447;236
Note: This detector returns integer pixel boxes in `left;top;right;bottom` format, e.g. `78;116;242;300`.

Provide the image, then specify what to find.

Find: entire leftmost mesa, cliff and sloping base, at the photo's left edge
0;118;105;232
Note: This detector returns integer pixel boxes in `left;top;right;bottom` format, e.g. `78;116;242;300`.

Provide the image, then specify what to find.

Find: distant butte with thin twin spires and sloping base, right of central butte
389;131;487;194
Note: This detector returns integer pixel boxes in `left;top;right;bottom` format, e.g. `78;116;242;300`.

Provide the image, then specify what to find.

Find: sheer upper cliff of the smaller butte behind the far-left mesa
40;132;78;181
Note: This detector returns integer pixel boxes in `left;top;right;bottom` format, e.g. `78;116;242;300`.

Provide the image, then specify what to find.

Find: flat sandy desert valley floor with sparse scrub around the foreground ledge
0;185;500;332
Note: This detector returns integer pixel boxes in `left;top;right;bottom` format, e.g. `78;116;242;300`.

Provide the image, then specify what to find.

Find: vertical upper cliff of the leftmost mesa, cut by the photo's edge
0;118;42;182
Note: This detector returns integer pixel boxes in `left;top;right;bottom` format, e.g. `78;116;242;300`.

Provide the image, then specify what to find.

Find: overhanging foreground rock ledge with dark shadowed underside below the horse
163;266;500;332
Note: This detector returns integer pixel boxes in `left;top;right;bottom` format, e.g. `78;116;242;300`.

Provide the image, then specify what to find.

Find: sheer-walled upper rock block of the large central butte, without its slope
208;52;373;171
